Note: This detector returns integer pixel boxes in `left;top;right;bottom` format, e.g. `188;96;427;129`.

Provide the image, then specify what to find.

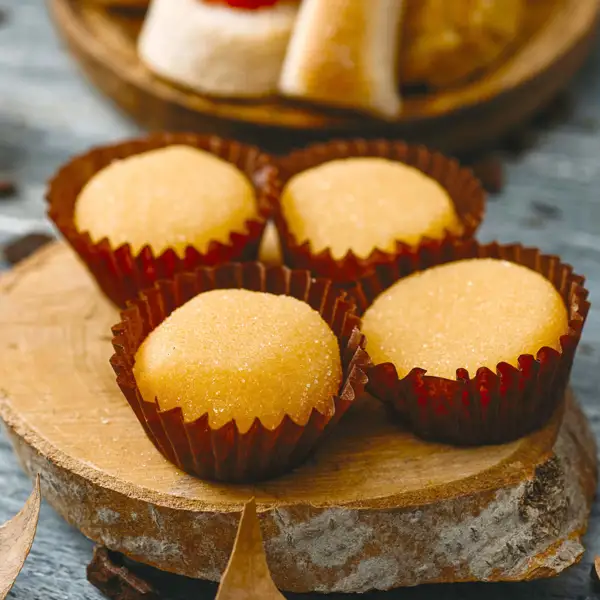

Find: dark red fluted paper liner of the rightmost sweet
349;240;590;445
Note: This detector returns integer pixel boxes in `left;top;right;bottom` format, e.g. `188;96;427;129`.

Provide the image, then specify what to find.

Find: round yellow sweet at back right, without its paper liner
281;158;462;259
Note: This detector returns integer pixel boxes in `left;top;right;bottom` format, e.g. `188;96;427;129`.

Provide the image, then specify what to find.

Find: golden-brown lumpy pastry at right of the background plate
400;0;524;87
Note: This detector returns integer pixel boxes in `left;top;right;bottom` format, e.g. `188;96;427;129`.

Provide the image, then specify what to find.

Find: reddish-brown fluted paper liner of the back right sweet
275;139;485;284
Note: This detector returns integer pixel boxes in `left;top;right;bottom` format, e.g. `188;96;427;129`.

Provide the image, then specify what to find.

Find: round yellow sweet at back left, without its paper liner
75;145;257;256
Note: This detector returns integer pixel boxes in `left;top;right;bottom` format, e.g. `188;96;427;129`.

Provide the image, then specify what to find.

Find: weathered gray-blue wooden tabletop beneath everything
0;0;600;600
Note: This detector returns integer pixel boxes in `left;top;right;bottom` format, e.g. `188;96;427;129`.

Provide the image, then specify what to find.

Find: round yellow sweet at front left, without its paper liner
134;289;342;433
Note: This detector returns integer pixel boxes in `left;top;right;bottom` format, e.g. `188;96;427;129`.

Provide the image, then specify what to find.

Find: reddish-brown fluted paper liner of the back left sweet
46;133;279;307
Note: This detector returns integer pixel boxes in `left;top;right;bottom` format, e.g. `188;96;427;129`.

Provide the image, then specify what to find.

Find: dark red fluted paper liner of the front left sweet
111;263;370;482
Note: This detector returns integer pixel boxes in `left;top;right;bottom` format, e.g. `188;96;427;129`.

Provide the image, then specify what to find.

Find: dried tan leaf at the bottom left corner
0;475;41;600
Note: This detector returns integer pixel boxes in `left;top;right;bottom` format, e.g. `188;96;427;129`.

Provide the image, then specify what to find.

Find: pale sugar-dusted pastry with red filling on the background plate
139;0;298;98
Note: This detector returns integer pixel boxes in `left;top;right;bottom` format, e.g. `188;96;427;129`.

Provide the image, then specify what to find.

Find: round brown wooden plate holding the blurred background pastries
49;0;599;153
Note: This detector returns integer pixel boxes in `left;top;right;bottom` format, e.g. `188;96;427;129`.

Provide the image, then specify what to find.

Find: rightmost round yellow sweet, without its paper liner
363;259;568;379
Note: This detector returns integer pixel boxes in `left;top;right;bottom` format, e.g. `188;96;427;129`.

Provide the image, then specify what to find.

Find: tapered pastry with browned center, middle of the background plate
279;0;404;118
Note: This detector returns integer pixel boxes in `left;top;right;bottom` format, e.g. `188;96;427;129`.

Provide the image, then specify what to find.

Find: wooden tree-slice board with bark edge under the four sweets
0;243;596;592
